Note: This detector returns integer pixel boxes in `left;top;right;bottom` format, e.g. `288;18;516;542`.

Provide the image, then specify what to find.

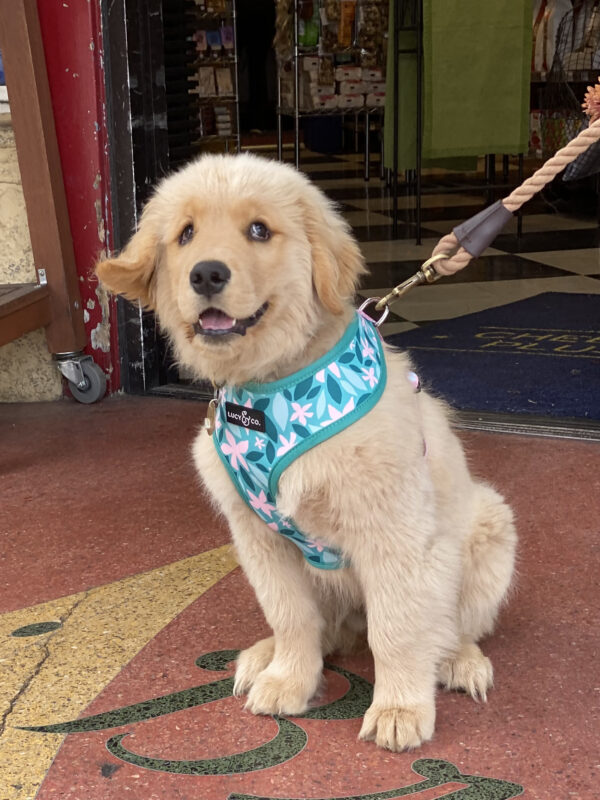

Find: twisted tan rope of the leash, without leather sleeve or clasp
432;119;600;275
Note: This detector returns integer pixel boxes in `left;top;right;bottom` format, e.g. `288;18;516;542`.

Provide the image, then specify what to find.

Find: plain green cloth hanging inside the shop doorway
385;0;532;170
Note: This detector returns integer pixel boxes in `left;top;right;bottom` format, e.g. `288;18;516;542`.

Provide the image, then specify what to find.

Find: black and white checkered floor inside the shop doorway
286;151;600;335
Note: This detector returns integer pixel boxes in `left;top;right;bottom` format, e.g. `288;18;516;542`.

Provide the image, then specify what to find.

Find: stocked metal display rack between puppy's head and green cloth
276;0;387;180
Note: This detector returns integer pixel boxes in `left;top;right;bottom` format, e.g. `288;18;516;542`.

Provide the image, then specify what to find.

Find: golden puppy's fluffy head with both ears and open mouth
97;155;364;383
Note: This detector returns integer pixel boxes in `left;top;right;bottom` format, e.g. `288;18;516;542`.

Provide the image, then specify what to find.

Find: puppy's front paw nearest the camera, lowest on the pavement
359;703;435;752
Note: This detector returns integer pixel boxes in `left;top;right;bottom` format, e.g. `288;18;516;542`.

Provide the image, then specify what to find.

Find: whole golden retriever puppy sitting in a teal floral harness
97;155;516;750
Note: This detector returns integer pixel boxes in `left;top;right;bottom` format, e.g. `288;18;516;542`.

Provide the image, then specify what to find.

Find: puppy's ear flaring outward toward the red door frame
96;214;158;310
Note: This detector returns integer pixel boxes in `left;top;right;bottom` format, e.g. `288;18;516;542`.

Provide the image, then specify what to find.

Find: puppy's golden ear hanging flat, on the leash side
305;194;367;314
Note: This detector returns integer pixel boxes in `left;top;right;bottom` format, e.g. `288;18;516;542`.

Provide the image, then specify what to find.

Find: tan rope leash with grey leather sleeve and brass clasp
375;83;600;316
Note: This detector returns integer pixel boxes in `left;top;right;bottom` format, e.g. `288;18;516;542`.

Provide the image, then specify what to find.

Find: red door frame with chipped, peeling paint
37;0;120;391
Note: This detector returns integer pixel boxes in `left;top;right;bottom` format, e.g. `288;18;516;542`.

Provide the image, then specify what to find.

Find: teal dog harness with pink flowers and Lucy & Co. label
213;312;386;569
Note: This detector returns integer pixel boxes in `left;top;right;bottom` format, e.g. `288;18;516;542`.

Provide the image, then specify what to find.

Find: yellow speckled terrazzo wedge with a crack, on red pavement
0;545;237;800
